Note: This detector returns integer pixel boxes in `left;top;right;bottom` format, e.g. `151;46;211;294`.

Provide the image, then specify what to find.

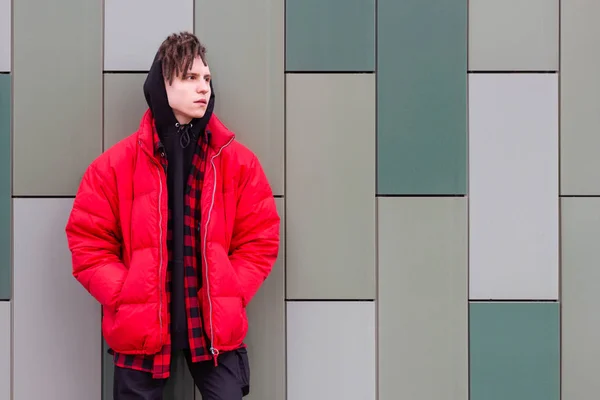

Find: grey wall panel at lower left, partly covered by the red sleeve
13;199;102;400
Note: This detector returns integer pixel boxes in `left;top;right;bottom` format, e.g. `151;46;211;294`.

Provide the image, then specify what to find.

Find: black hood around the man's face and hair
144;53;215;144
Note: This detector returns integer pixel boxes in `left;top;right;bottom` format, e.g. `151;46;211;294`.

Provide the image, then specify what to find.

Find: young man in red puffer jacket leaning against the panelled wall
66;32;280;400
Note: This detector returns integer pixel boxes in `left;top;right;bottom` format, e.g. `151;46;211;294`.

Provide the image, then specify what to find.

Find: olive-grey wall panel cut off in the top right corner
560;0;600;195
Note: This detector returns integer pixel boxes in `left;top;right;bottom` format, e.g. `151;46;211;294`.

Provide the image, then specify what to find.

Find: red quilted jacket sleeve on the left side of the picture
66;164;127;309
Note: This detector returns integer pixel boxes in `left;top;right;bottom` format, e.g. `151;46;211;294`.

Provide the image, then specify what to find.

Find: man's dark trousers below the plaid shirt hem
113;348;250;400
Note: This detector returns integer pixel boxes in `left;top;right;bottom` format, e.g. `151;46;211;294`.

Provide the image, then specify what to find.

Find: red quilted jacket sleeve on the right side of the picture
229;157;280;306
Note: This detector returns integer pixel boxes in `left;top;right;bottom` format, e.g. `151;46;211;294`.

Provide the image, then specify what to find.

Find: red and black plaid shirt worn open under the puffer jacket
110;130;212;379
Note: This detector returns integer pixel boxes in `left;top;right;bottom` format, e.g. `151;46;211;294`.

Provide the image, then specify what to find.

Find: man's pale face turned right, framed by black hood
165;57;210;124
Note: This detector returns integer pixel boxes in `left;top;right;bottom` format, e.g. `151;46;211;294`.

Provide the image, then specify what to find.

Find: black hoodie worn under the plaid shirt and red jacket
144;53;215;351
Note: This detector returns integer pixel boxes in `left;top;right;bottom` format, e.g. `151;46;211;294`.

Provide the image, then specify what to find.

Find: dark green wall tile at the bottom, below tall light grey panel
469;302;560;400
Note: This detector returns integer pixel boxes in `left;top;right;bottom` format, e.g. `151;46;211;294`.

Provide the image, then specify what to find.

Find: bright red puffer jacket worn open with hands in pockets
66;111;280;360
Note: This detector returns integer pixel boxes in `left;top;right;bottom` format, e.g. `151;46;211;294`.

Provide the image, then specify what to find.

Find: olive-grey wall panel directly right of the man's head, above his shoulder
195;0;284;195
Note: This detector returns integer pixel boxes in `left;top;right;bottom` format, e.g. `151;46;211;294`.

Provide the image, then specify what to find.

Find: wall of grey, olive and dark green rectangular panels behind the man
0;0;600;400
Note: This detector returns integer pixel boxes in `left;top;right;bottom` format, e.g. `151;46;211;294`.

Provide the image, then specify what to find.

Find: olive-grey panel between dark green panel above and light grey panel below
286;74;375;299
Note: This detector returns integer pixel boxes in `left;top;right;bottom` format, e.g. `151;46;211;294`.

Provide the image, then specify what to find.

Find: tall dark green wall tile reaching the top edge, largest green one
377;0;467;194
